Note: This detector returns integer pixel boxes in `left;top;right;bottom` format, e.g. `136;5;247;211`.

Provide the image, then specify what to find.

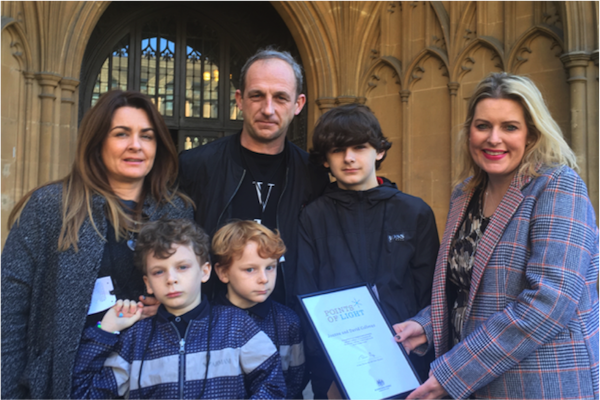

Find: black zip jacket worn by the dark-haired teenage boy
296;179;439;399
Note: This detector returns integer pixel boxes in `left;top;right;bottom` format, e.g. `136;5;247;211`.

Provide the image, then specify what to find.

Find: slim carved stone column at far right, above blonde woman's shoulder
560;52;590;182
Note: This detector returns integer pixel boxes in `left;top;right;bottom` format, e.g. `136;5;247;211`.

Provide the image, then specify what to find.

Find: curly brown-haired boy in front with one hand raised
72;220;285;399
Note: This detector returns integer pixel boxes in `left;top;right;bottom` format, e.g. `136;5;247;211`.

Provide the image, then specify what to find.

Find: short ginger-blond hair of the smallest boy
212;221;286;271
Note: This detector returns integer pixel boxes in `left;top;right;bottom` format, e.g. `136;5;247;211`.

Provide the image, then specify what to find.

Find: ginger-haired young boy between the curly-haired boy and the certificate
212;221;304;399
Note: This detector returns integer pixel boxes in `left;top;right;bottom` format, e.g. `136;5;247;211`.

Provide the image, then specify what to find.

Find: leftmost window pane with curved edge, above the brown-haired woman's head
92;35;129;107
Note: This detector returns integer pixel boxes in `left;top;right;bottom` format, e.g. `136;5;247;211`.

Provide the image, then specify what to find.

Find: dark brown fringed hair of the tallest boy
310;103;392;169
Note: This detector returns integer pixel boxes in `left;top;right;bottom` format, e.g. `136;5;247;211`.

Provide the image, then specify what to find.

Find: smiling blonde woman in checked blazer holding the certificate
394;73;600;400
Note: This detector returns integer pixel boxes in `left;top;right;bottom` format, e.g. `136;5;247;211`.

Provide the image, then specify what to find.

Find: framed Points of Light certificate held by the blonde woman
298;284;421;400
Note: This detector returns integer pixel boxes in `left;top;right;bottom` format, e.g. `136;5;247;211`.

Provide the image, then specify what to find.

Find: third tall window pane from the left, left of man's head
185;20;220;119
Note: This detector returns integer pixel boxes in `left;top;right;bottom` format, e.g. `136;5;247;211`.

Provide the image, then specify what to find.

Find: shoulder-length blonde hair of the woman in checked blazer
454;72;578;191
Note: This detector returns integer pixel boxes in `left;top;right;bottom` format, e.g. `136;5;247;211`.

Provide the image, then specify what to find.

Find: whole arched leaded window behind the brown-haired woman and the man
85;10;304;151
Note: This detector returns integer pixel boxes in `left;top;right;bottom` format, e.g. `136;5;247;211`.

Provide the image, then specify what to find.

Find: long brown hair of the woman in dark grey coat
8;90;191;251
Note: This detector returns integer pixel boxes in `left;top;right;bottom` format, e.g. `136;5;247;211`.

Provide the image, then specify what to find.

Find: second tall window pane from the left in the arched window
140;20;176;117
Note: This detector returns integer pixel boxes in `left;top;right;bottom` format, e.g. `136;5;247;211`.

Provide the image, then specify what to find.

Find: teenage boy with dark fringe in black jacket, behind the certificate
296;104;439;399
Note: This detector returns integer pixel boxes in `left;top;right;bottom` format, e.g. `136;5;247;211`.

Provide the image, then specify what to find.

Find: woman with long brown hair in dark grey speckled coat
0;90;193;399
